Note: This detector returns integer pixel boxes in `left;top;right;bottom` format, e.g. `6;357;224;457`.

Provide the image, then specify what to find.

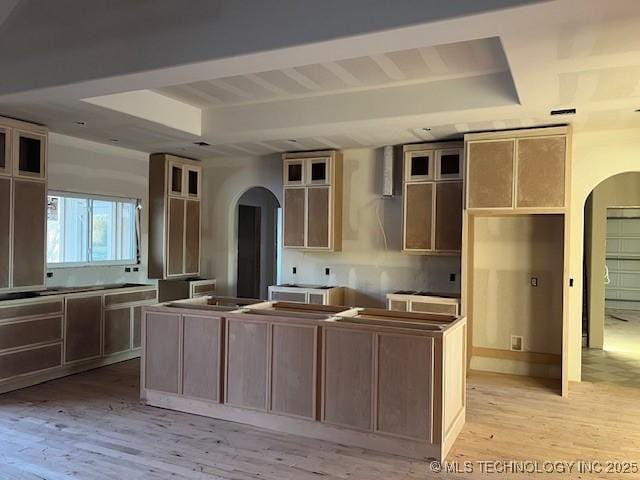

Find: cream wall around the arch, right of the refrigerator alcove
567;128;640;381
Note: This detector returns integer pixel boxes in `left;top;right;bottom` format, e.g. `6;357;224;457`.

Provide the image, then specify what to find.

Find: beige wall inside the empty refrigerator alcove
471;215;564;377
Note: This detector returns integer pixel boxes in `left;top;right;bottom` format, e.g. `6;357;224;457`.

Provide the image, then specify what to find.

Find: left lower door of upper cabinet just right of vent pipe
404;183;434;251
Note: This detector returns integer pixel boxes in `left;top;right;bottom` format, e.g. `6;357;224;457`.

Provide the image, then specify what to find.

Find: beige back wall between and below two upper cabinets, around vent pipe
282;149;460;307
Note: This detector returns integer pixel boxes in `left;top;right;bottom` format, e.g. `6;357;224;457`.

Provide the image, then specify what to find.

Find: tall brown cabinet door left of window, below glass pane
13;179;47;288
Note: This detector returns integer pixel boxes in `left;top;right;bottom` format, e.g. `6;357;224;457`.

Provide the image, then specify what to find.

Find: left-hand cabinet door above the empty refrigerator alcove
467;140;515;208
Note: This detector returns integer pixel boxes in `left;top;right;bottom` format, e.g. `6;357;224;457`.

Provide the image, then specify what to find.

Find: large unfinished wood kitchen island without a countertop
141;298;466;460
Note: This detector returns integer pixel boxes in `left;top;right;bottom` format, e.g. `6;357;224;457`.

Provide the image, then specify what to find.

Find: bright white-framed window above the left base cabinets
47;192;139;267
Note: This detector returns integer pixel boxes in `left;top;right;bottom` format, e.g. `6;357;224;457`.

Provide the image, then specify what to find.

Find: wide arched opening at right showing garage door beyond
582;172;640;388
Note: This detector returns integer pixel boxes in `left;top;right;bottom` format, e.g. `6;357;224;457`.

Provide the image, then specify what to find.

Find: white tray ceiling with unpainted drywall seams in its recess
0;0;640;158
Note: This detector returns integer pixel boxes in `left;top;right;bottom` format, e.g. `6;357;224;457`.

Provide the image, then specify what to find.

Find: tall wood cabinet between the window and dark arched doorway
149;154;202;279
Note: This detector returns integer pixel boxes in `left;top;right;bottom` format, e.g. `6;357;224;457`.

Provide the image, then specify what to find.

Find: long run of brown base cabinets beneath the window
0;286;157;393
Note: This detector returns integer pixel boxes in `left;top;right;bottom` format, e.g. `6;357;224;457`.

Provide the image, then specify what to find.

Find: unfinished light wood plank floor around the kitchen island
0;361;640;480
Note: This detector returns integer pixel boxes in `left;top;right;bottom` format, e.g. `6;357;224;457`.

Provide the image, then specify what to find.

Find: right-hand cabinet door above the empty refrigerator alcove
516;136;566;208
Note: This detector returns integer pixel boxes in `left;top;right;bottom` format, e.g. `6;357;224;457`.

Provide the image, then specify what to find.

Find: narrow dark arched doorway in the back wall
235;187;280;299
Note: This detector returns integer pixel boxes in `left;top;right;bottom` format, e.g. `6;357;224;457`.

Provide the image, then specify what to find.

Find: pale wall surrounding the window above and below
47;133;149;286
